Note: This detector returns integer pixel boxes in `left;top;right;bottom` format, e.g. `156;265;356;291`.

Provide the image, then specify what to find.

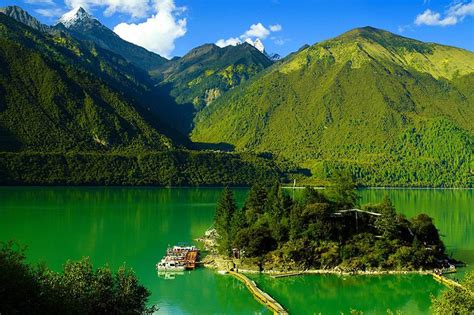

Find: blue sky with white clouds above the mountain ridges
0;0;474;57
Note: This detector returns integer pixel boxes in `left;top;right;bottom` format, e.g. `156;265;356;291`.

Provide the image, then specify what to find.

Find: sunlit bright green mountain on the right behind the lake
191;27;474;186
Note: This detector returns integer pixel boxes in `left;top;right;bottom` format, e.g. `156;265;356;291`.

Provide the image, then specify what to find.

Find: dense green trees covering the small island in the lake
215;175;447;271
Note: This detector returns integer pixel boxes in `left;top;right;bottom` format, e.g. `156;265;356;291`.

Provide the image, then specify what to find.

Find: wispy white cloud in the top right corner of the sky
415;0;474;26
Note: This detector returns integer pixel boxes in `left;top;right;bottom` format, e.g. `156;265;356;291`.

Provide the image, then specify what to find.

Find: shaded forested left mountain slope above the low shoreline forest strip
0;14;171;151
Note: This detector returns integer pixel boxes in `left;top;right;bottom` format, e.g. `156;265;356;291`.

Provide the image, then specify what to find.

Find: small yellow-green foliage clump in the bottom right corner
432;271;474;315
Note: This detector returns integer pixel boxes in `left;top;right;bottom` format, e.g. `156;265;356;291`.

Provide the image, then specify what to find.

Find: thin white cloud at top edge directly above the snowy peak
64;0;150;18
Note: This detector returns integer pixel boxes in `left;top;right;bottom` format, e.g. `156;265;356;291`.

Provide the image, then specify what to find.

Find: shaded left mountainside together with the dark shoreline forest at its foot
0;13;283;185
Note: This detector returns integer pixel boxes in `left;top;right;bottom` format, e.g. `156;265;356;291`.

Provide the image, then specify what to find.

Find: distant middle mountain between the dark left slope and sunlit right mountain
151;43;272;110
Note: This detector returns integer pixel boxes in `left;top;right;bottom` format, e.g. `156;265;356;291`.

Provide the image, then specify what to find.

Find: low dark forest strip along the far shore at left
0;150;285;186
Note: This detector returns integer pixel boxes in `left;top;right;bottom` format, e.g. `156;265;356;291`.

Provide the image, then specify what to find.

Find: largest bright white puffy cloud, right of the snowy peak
114;0;187;58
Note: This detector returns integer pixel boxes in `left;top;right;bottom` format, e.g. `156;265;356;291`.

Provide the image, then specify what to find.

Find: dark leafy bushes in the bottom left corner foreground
0;242;154;314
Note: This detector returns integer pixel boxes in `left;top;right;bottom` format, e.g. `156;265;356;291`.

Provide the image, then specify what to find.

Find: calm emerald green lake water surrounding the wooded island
0;187;474;314
